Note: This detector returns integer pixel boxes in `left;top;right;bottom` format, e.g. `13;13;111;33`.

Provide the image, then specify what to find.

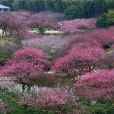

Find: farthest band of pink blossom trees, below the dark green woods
0;11;113;40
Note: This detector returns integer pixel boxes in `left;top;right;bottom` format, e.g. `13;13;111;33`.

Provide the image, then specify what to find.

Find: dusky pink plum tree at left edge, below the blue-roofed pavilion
0;13;33;38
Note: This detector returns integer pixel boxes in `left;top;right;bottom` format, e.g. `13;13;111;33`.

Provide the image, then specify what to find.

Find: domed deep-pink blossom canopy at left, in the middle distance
1;48;50;82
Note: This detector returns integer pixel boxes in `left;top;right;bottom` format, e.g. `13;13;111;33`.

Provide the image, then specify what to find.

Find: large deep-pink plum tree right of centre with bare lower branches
53;43;105;79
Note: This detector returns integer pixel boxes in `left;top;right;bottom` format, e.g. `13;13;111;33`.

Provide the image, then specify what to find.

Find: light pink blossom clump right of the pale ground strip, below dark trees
59;19;96;33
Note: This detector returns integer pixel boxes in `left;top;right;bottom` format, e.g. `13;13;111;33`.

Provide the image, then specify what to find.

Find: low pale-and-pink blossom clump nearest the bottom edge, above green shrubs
20;89;72;107
